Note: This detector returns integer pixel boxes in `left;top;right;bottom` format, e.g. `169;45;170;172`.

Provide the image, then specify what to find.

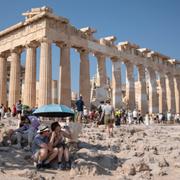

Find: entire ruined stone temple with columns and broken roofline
0;7;180;114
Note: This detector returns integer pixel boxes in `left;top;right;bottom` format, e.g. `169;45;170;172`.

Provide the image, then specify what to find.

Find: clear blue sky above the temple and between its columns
0;0;180;91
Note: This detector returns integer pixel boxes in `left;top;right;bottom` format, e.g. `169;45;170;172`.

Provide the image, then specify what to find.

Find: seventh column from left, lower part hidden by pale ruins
96;54;106;87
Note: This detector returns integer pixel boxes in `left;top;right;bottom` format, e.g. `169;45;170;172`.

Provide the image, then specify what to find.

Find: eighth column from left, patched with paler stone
112;59;122;108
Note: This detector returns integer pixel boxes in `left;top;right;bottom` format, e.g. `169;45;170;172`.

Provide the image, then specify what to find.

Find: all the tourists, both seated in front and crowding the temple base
0;96;180;170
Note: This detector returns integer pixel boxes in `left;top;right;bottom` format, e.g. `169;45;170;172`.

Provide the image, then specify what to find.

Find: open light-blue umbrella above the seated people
33;104;74;117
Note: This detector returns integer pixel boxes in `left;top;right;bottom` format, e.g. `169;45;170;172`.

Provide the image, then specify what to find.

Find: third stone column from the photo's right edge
159;73;167;113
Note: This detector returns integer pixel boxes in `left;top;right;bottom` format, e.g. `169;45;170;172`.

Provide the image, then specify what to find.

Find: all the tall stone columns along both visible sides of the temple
0;38;180;114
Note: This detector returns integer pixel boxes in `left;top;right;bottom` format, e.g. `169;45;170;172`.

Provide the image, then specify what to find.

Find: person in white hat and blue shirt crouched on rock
32;125;58;169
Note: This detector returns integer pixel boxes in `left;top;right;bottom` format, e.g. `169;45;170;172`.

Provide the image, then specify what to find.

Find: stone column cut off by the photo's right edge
174;76;180;113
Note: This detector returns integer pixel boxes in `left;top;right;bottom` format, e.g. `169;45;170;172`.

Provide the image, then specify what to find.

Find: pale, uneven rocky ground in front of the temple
0;119;180;180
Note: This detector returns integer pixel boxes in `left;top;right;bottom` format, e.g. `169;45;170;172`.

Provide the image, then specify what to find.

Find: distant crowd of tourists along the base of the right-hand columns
82;100;180;126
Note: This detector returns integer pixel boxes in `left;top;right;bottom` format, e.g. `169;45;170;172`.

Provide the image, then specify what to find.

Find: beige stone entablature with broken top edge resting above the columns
0;7;180;74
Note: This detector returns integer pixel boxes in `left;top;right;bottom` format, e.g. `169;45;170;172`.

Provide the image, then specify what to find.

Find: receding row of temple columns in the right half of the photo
97;56;180;114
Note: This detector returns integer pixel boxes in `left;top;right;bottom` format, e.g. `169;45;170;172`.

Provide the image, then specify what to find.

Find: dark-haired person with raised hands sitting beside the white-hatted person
50;122;71;170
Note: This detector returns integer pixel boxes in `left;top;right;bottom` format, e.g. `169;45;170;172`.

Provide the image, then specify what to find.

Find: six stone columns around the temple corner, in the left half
0;38;90;107
